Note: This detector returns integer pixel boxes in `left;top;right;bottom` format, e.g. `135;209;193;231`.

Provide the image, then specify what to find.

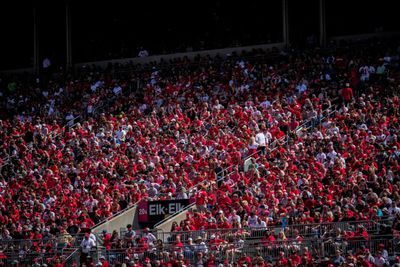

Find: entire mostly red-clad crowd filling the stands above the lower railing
0;38;400;266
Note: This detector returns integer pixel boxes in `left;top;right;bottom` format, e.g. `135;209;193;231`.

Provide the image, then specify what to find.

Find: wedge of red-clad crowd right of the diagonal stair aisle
179;91;400;230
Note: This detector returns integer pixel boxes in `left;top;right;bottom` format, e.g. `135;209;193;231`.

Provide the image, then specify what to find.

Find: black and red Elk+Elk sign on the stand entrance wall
138;199;189;223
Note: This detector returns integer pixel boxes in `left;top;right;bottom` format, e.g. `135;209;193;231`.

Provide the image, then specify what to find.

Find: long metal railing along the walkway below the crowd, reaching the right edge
88;235;400;264
